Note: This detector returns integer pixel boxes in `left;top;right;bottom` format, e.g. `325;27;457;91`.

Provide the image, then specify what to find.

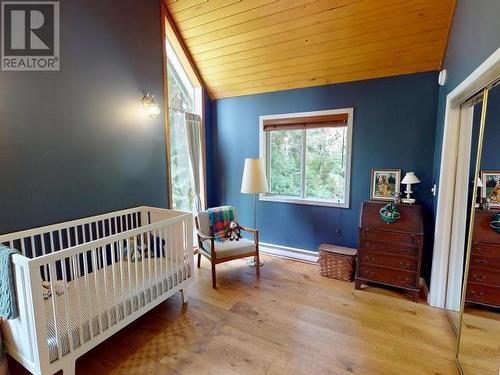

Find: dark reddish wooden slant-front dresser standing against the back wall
355;201;424;302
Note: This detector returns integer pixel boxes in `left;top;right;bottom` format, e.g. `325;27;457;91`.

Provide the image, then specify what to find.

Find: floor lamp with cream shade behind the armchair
241;159;267;267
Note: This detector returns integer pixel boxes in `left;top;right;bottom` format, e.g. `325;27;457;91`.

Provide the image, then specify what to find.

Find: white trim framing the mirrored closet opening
428;48;500;307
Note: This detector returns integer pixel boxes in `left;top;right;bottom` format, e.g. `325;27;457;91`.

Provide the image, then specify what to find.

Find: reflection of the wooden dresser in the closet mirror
465;209;500;307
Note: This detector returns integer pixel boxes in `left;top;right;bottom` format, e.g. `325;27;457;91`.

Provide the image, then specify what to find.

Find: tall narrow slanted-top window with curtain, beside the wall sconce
164;13;205;212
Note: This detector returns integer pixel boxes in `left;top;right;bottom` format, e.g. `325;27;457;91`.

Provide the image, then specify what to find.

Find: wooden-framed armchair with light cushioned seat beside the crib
195;210;260;289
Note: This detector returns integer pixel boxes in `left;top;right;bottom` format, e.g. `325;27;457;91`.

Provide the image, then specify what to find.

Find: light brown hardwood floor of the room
11;257;458;375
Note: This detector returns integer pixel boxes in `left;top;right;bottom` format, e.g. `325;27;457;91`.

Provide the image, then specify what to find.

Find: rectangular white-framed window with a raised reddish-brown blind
260;108;353;207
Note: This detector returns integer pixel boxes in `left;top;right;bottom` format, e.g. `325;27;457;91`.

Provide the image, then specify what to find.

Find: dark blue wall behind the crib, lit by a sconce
0;0;167;233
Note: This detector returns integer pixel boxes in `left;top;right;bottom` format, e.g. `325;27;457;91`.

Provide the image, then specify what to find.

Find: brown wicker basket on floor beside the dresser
318;244;357;281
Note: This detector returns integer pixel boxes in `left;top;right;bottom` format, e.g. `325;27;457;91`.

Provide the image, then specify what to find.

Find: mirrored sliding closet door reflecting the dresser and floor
458;86;500;375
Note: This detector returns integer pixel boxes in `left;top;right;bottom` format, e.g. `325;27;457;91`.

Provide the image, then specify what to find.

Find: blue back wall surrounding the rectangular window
213;72;438;275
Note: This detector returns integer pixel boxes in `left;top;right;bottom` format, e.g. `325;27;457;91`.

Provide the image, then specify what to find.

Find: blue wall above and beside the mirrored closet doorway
433;0;500;211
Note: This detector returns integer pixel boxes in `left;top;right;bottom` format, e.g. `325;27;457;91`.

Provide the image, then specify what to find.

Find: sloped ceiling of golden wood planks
165;0;455;99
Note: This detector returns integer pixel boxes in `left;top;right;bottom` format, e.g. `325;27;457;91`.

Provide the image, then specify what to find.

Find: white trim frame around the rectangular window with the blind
259;108;354;208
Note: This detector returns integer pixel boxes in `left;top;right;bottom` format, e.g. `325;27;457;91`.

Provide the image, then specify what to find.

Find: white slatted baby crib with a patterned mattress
0;206;193;375
